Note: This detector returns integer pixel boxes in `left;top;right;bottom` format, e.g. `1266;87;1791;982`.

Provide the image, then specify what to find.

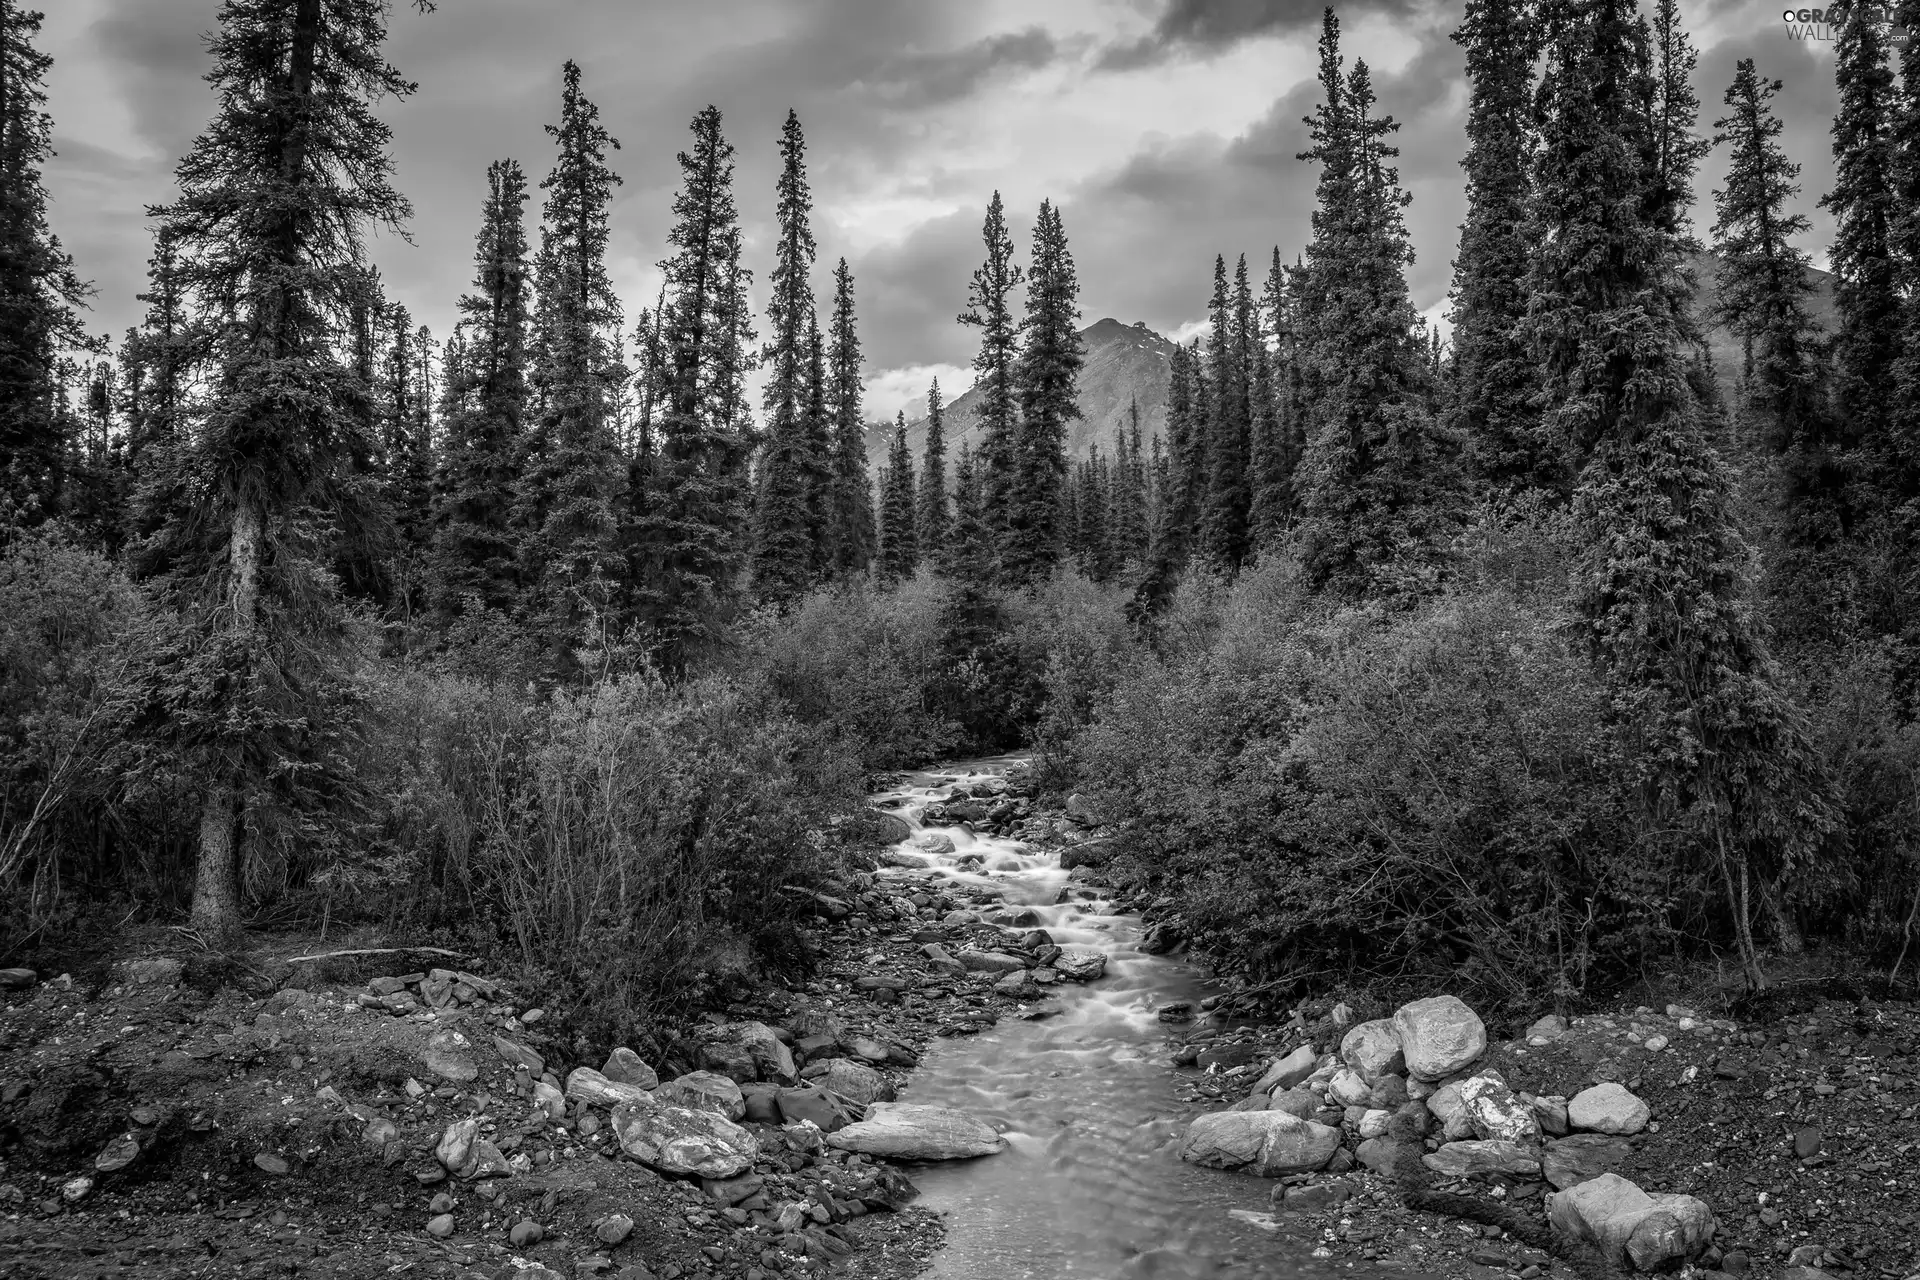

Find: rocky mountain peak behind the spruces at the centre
866;319;1173;476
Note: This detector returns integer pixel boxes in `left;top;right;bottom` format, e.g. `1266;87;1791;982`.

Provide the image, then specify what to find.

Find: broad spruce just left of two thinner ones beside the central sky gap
636;106;753;674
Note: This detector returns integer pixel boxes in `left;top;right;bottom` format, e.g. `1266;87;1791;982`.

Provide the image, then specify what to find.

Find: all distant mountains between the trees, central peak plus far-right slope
866;253;1839;476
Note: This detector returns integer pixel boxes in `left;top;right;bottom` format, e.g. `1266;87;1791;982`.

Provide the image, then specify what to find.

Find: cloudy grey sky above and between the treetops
42;0;1834;418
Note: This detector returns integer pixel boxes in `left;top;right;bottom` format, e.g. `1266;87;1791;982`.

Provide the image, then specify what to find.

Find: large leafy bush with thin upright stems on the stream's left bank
357;674;858;1040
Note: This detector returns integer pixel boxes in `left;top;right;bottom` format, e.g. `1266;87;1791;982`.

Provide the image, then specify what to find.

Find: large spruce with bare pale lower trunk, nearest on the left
146;0;426;936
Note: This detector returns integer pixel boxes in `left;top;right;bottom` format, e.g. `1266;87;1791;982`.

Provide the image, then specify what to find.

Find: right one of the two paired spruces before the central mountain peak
1006;200;1087;583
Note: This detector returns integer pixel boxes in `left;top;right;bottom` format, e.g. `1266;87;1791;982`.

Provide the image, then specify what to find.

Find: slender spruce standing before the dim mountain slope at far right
1711;58;1839;466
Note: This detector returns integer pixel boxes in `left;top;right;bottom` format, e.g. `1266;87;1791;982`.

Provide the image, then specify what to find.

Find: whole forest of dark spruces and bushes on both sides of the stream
0;0;1920;1025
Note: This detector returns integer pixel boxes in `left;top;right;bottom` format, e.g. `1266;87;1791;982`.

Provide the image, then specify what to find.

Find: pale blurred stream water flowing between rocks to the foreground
876;760;1352;1280
